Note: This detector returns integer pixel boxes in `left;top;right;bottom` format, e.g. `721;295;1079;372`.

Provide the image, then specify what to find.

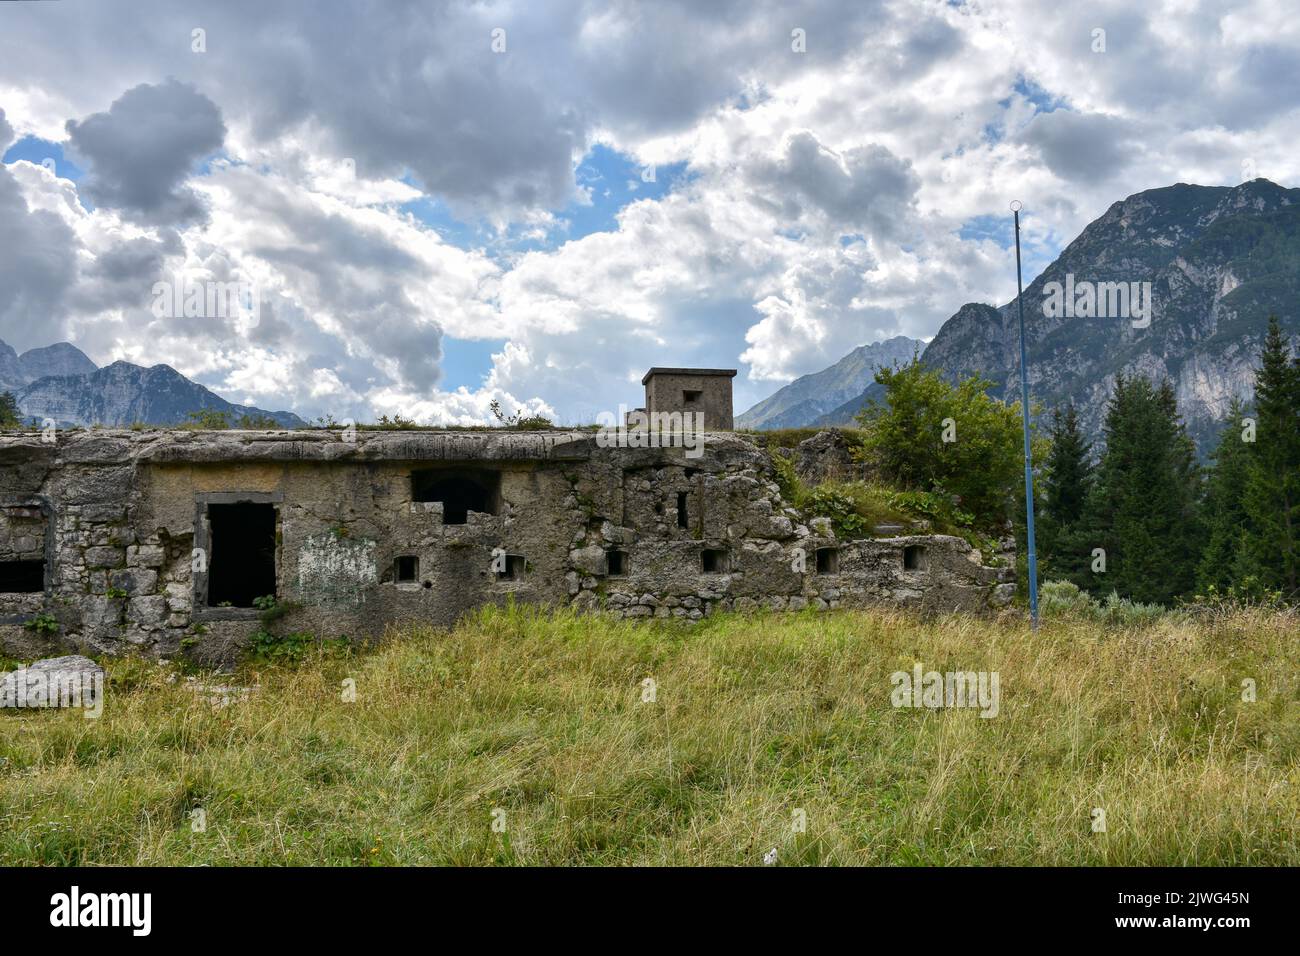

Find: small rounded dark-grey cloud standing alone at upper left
68;79;226;225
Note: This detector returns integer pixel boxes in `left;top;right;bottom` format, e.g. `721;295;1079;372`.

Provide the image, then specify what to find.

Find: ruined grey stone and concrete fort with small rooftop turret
0;369;1013;662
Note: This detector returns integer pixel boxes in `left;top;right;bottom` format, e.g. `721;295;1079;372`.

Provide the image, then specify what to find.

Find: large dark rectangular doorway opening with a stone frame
208;501;276;607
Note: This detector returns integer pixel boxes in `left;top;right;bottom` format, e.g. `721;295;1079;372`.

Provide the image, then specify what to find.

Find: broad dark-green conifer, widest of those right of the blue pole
1086;376;1200;604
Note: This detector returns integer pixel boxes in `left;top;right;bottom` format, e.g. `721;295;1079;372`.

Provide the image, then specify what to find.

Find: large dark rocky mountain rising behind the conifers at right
820;179;1300;451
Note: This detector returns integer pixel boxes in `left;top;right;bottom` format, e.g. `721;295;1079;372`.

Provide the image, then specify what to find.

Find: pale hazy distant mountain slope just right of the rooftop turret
736;336;926;428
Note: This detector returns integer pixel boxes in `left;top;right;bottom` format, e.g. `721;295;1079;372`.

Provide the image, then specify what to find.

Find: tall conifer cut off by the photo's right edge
1245;316;1300;598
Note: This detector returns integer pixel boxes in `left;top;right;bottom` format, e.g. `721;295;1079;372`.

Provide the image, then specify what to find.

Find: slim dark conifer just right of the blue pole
1039;405;1092;584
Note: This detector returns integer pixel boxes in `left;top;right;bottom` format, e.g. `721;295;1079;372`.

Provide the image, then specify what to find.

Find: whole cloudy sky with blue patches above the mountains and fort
0;0;1300;424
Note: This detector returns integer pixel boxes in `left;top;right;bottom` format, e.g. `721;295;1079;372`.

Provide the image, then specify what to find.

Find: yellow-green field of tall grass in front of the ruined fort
0;607;1300;865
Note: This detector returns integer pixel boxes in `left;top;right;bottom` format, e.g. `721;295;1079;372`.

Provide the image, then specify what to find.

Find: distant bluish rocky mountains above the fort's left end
0;342;306;427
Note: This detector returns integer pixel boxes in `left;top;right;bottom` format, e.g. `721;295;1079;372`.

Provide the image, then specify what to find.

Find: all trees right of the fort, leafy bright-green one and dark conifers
858;317;1300;605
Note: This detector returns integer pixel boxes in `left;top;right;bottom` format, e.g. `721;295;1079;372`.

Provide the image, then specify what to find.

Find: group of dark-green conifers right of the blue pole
1035;317;1300;605
